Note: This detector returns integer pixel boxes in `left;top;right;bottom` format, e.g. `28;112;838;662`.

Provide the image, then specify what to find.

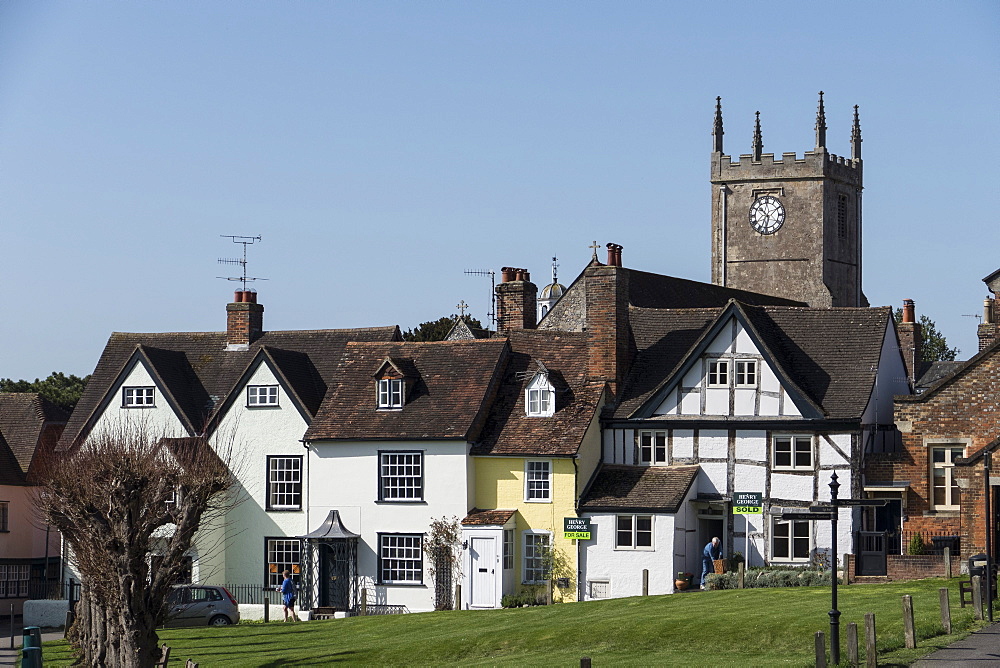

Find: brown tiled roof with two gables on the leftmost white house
60;326;400;448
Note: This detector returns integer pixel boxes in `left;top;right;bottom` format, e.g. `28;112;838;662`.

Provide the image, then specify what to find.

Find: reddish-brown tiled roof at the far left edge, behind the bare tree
0;392;69;485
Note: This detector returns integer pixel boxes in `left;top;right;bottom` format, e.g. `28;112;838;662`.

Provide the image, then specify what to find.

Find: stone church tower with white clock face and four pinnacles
711;92;868;306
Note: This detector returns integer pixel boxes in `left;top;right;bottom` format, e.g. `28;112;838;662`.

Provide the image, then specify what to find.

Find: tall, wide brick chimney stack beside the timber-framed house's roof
584;244;632;394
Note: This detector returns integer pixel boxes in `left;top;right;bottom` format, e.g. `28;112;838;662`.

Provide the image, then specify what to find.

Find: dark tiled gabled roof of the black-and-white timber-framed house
614;302;892;419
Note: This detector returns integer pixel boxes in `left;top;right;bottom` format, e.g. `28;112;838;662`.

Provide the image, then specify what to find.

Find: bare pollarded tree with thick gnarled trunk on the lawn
37;423;232;668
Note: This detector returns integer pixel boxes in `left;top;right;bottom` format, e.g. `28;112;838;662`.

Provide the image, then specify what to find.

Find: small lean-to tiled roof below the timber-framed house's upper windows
580;464;700;513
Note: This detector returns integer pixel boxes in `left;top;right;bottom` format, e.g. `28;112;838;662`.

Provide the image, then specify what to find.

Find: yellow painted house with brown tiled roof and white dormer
462;330;606;608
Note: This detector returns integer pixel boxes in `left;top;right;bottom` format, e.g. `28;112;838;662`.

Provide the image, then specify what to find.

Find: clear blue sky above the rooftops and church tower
0;0;1000;379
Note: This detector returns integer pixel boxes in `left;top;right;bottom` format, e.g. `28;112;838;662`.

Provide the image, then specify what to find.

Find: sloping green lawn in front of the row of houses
44;578;982;668
